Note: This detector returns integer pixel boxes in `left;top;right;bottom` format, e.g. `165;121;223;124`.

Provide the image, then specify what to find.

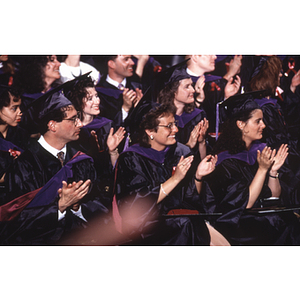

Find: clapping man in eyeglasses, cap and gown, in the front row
0;92;109;245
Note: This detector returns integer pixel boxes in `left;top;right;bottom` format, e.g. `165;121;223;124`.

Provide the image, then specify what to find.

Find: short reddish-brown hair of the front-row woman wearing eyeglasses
138;103;176;148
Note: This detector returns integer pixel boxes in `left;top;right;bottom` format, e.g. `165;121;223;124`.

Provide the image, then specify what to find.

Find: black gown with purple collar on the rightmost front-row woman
203;143;300;245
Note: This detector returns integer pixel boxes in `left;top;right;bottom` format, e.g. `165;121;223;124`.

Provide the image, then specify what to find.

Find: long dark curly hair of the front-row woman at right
212;108;257;154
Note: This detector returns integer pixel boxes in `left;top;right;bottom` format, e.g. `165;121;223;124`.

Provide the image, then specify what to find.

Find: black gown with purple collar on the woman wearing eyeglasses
115;143;210;245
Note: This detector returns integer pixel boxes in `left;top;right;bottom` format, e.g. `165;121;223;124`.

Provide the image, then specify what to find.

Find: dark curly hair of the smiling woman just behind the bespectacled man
68;77;95;118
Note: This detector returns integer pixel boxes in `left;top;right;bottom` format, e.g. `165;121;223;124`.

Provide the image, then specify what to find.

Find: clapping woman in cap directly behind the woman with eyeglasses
158;68;208;158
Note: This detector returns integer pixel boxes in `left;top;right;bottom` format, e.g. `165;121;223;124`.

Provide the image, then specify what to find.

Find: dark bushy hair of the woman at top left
14;55;59;94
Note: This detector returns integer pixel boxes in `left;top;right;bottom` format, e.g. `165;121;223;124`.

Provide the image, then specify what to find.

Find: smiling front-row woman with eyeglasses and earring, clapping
115;105;228;245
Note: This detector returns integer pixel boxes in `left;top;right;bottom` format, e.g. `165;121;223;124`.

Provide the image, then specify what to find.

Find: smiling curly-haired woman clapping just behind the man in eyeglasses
64;72;125;209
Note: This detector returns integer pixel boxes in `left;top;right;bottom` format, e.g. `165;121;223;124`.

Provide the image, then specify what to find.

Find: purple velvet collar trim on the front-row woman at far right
216;141;266;165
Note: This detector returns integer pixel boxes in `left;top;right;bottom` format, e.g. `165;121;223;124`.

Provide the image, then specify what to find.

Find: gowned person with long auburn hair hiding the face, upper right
249;56;300;203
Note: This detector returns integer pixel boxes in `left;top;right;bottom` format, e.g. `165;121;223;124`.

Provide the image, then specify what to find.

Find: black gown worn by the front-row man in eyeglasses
0;142;110;245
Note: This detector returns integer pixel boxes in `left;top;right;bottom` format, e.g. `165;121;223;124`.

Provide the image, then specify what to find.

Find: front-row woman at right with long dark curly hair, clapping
204;97;300;245
